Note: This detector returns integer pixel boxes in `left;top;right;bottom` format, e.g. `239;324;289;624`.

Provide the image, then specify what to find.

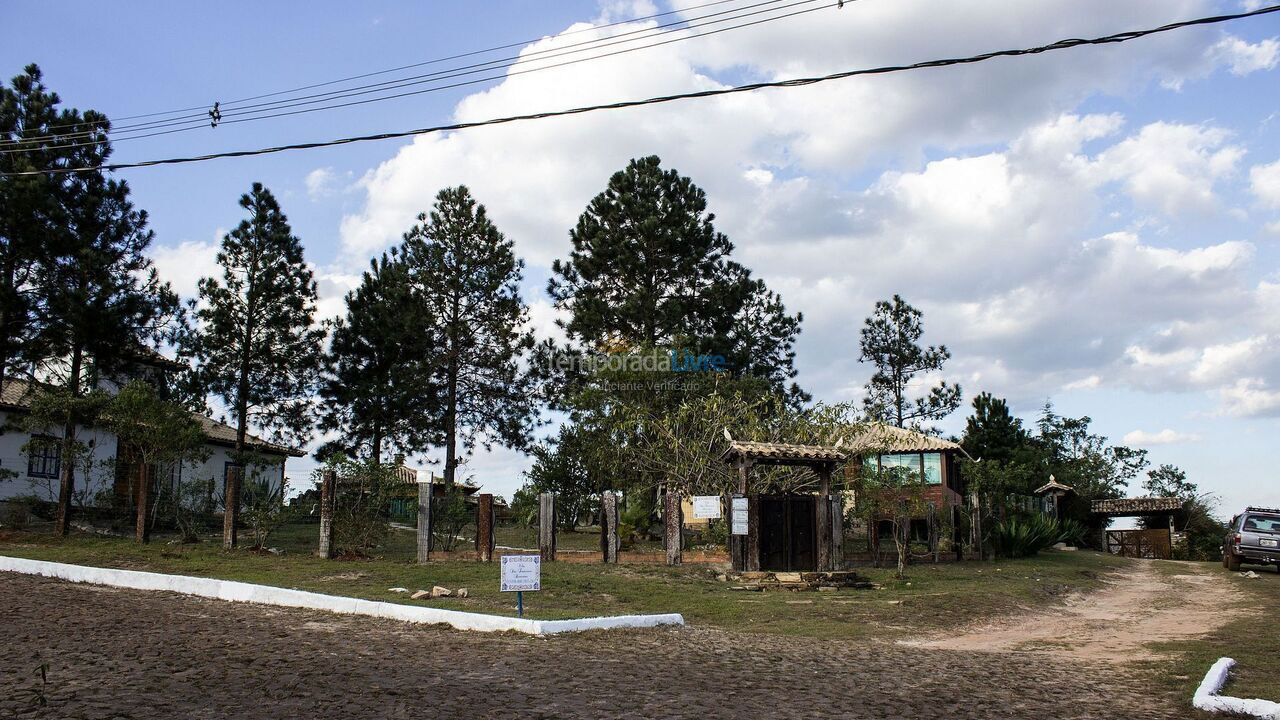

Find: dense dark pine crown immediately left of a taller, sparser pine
320;255;442;462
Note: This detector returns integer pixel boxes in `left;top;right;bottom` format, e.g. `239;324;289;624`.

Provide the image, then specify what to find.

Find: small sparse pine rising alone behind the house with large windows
859;295;960;428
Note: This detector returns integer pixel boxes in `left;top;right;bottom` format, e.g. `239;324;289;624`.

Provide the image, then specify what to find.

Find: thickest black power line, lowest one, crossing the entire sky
12;5;1280;177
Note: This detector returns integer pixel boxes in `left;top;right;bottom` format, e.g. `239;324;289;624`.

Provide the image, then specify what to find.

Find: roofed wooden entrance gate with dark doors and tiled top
722;433;847;571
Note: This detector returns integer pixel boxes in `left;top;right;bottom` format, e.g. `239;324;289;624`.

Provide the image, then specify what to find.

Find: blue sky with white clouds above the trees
0;0;1280;514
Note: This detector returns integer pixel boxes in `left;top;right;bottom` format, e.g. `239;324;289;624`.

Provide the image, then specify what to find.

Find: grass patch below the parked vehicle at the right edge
1152;562;1280;702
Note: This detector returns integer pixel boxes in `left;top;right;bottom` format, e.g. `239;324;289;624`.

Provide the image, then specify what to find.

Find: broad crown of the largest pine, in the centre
547;156;801;393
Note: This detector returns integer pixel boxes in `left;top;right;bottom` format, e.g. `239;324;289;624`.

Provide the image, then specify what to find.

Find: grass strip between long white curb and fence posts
0;525;1129;639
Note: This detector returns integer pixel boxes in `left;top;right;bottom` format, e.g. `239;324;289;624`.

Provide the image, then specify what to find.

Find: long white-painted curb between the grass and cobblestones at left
0;555;685;635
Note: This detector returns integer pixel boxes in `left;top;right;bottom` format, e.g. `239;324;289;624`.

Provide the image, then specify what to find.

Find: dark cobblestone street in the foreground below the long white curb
0;573;1185;720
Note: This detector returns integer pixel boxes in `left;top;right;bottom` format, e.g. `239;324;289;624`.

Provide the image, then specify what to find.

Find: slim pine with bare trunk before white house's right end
182;183;325;548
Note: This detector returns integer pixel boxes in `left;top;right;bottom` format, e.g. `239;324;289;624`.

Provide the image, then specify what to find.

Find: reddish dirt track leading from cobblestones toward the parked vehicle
902;562;1238;662
